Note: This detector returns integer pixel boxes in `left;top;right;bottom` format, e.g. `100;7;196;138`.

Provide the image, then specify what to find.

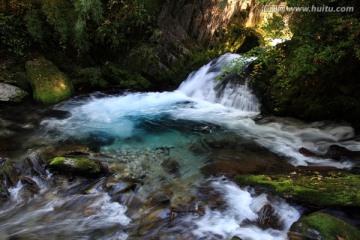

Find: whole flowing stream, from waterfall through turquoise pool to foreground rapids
0;54;360;240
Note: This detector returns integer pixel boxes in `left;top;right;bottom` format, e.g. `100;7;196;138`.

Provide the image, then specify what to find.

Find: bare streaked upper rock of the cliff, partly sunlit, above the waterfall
158;0;257;64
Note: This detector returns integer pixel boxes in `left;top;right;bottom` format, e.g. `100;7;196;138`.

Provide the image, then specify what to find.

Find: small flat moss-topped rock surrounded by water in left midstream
49;157;108;177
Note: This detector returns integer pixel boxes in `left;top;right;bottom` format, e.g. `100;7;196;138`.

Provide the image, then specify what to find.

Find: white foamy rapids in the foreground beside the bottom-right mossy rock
187;179;300;240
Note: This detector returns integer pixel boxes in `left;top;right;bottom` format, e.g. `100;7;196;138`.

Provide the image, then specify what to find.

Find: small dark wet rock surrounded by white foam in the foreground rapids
257;204;284;230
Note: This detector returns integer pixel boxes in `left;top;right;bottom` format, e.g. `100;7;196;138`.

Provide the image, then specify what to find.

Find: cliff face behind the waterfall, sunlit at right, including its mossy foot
129;0;260;84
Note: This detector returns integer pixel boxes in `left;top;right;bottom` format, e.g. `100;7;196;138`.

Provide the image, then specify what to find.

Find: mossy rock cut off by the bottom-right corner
288;212;360;240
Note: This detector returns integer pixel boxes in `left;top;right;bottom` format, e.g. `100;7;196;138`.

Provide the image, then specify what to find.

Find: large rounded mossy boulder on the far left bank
25;57;73;105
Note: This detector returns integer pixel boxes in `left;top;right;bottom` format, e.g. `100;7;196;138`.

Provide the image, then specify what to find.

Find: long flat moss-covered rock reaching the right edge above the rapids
236;171;360;207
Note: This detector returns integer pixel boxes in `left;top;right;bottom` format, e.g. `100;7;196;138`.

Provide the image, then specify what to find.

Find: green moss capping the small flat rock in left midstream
49;157;101;175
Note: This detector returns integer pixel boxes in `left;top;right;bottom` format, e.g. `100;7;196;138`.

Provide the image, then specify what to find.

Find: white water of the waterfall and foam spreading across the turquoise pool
42;54;360;168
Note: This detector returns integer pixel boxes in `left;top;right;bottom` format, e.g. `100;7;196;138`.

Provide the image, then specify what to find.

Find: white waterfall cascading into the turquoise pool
178;53;260;112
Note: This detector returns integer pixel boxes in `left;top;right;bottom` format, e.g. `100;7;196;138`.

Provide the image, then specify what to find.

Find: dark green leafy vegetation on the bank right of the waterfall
217;0;360;122
